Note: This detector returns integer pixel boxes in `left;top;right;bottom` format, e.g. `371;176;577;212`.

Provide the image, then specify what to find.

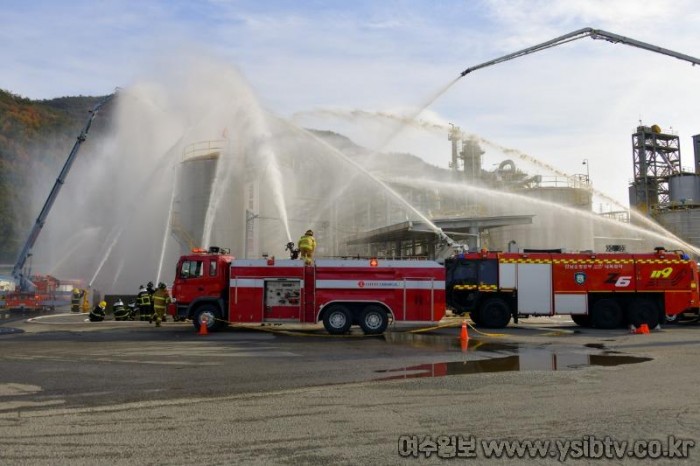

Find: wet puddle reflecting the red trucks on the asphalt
375;335;651;380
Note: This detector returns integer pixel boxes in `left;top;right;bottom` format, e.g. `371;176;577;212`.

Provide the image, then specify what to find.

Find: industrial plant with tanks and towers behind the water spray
170;125;700;258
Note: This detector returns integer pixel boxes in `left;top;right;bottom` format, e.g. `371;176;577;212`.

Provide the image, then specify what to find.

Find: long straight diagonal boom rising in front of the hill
12;94;115;291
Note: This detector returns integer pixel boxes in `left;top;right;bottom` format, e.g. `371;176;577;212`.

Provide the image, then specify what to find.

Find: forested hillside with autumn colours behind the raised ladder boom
0;89;109;263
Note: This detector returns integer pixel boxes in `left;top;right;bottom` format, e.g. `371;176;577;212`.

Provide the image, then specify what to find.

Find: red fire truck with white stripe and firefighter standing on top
170;247;445;334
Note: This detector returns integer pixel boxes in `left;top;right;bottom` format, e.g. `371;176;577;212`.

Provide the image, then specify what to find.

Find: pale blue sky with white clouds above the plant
0;0;700;202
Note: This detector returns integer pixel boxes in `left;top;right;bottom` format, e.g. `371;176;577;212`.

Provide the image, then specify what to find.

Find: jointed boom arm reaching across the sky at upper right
460;28;700;77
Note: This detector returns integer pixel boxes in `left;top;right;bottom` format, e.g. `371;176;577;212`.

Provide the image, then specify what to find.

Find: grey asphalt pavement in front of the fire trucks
0;312;700;465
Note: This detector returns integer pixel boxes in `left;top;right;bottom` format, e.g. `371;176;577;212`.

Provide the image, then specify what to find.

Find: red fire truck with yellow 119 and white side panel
445;248;700;329
